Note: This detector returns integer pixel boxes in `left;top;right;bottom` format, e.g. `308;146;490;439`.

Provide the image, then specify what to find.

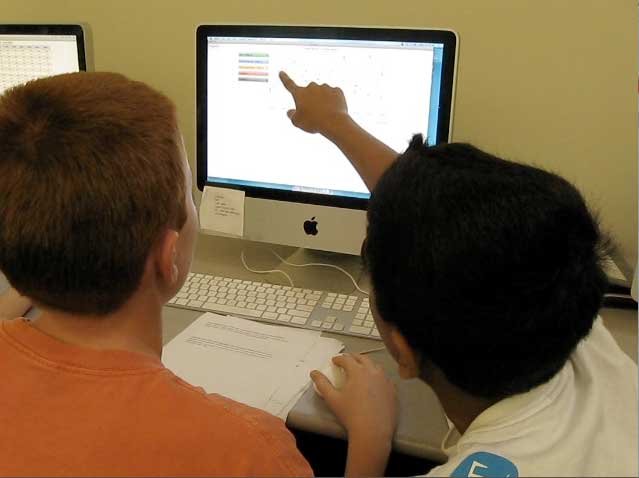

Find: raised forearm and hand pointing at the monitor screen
280;71;398;191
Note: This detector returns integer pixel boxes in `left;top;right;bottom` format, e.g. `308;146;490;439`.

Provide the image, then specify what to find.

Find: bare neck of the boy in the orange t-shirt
32;296;162;358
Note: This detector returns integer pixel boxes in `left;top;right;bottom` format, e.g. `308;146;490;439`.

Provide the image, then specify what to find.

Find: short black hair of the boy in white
364;135;608;399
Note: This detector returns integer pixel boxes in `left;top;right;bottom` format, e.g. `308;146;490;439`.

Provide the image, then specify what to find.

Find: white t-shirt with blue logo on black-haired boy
426;318;638;476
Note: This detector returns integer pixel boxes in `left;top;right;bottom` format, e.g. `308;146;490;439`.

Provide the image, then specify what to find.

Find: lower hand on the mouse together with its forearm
311;354;397;477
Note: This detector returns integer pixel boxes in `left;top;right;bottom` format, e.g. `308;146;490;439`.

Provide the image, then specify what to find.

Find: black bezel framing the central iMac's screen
196;25;457;210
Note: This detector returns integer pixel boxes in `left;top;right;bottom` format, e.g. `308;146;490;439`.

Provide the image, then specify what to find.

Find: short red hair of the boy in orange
0;73;186;315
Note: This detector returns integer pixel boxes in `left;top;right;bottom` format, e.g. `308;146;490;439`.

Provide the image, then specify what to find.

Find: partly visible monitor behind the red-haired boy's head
0;25;86;95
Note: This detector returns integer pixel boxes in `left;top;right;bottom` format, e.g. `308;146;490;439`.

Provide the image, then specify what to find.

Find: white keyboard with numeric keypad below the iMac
169;273;381;340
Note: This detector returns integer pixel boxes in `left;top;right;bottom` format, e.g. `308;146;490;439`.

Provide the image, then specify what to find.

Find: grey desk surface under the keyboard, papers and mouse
164;235;637;461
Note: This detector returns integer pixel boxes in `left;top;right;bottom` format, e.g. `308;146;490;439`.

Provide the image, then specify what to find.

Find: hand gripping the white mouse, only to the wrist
311;354;397;462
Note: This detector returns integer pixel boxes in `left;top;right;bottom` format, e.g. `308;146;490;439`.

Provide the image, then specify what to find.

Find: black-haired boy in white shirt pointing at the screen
281;73;637;476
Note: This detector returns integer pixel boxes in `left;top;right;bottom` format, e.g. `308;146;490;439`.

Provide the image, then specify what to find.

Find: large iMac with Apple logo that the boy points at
196;25;457;255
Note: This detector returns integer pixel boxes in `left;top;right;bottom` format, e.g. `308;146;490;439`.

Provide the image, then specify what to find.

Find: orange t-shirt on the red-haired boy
0;319;313;476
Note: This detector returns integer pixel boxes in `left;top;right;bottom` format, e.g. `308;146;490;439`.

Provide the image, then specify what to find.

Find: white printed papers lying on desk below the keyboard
162;313;343;419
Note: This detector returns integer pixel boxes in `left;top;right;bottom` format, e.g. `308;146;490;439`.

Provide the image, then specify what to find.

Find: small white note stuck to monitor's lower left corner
200;186;244;237
